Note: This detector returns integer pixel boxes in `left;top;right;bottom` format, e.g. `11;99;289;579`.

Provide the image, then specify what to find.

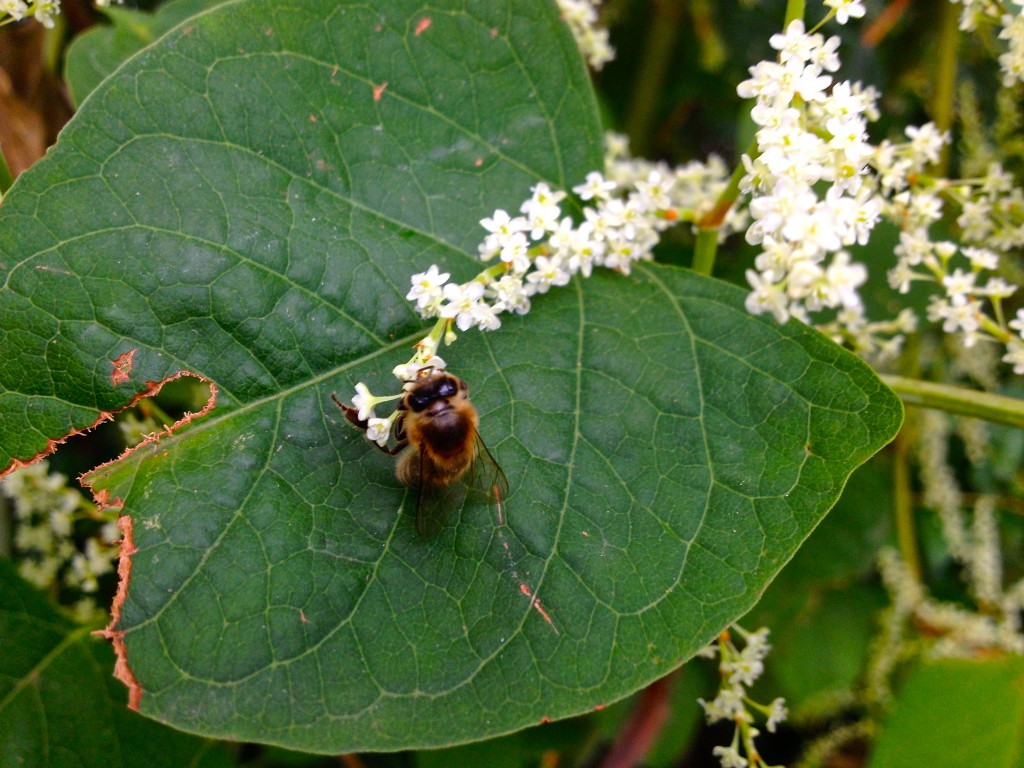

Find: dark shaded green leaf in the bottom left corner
0;558;233;768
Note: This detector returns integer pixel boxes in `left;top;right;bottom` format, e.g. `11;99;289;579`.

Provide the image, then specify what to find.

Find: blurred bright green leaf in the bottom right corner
868;656;1024;768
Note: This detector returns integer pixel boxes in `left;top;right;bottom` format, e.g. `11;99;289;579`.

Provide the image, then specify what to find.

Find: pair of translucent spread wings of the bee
416;433;509;539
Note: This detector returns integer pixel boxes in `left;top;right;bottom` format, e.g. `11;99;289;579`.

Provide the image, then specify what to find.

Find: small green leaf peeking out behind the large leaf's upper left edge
65;0;230;105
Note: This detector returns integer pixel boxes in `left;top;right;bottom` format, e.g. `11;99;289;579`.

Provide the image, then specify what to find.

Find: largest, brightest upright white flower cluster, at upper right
737;19;882;323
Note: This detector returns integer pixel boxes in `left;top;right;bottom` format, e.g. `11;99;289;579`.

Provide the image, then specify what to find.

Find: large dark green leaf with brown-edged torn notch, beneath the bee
0;0;901;753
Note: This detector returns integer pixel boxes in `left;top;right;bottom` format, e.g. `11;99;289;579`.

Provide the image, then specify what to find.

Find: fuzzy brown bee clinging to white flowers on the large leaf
331;367;509;539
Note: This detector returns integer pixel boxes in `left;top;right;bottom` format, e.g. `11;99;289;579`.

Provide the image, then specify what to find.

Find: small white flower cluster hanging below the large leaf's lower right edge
697;625;787;768
